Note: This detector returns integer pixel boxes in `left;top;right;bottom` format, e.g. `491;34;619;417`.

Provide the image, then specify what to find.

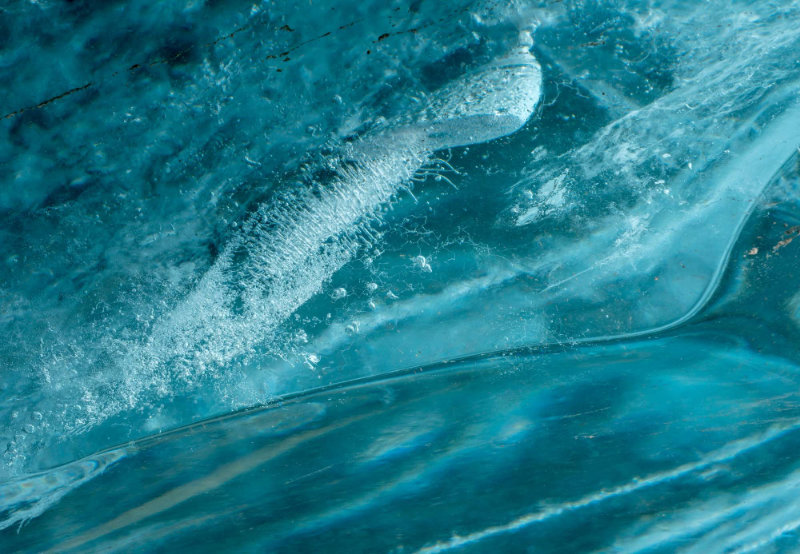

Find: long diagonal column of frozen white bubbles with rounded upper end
0;33;541;488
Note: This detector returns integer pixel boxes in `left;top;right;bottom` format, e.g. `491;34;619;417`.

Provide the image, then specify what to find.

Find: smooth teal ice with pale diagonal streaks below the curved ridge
7;221;800;552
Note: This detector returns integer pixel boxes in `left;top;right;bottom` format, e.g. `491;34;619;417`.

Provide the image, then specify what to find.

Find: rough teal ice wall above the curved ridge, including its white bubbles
0;1;800;492
